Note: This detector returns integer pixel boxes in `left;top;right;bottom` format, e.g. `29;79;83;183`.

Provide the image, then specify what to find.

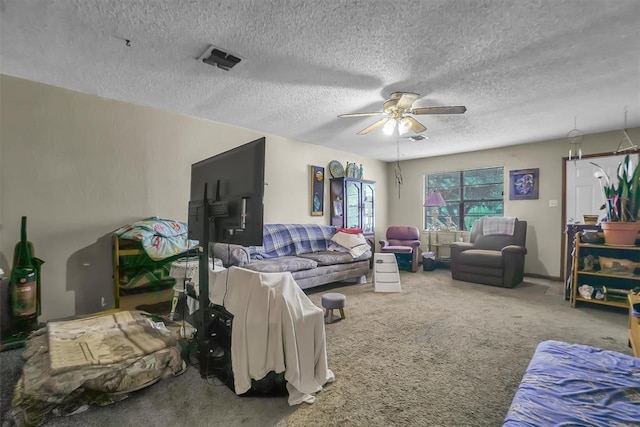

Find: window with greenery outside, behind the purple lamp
424;166;504;230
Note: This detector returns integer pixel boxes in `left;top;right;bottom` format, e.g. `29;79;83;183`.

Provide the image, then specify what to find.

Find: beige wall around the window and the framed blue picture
387;128;640;278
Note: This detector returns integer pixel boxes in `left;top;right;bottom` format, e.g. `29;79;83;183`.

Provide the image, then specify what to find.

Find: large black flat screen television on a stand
188;138;265;246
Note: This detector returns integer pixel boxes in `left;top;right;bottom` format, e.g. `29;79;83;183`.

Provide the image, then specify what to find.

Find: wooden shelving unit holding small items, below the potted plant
570;232;640;308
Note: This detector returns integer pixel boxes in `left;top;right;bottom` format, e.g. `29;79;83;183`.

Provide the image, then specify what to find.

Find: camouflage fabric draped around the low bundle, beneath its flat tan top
12;310;186;426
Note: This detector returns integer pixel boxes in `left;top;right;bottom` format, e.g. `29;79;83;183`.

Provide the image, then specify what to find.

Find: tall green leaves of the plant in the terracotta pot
590;154;640;222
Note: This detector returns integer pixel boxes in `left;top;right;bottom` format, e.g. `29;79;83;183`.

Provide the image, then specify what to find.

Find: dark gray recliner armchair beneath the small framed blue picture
451;217;527;288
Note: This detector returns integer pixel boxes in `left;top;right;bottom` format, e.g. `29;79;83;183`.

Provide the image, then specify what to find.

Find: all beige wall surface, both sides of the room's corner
0;75;640;321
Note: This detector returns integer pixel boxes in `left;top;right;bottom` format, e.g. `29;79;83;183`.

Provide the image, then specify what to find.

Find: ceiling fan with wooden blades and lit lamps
338;92;467;135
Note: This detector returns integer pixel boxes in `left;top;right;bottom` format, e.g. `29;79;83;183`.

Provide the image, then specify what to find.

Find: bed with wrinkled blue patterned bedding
503;341;640;427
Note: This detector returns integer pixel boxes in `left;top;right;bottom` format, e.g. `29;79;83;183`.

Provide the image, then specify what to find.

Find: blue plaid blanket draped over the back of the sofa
248;224;337;259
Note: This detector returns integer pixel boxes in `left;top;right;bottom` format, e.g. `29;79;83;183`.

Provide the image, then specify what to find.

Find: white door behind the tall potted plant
565;154;638;224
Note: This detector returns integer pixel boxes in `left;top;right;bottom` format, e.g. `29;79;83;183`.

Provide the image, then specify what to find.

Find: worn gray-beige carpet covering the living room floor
0;269;631;427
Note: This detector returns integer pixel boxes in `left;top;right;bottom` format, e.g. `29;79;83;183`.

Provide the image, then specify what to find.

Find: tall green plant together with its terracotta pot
591;154;640;245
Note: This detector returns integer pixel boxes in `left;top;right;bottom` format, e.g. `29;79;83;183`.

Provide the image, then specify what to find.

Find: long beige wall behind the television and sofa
0;75;387;321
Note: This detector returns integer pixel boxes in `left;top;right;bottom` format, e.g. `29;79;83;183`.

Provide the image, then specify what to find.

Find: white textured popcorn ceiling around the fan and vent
0;0;640;161
